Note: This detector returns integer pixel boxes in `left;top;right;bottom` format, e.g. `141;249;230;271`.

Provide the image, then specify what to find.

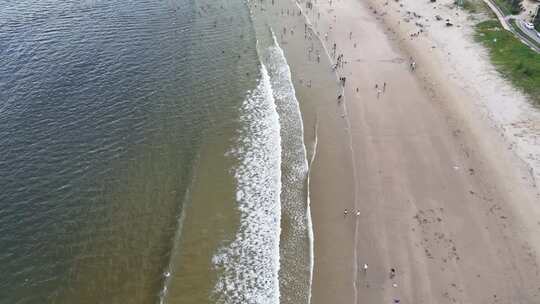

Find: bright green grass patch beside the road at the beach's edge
475;20;540;106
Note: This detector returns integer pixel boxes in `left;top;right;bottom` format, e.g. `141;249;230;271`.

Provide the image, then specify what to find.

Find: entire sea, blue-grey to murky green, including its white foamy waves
0;0;312;304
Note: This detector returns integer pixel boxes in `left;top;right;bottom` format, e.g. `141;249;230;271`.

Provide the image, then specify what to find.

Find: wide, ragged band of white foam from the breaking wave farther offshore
213;64;281;304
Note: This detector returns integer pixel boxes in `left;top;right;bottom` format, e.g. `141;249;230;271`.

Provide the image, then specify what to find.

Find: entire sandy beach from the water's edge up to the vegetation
253;0;540;304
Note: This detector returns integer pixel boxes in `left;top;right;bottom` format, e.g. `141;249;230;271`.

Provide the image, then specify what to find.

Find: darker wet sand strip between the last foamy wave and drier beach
251;0;353;303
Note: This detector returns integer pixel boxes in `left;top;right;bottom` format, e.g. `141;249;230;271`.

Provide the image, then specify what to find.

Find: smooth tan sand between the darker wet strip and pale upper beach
306;0;540;303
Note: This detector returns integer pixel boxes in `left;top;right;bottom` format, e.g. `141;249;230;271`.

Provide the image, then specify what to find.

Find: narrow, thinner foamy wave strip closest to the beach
263;31;313;303
